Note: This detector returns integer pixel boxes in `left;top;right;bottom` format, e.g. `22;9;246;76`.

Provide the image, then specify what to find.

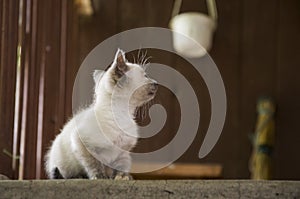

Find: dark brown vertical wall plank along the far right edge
274;0;300;180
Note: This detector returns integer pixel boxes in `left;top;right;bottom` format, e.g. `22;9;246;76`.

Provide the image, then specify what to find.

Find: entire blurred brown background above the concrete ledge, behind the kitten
0;0;300;180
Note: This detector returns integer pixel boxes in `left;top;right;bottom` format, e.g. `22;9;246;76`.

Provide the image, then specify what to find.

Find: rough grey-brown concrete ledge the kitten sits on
0;180;300;199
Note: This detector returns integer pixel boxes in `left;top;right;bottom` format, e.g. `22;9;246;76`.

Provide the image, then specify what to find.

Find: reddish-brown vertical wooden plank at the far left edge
0;0;19;178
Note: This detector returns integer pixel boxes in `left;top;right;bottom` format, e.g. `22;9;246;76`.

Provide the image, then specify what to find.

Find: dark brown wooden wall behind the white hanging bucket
74;0;300;179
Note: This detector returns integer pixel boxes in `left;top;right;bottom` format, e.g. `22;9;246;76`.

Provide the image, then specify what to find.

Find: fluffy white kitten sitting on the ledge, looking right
45;49;158;180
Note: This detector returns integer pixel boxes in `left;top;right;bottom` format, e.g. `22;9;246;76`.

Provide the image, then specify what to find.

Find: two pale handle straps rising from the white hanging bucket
172;0;218;21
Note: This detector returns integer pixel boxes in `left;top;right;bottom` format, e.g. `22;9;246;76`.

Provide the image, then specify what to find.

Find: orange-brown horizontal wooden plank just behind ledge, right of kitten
132;163;222;180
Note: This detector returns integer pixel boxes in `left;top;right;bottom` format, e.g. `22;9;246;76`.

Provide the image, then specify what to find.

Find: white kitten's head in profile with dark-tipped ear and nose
94;49;158;107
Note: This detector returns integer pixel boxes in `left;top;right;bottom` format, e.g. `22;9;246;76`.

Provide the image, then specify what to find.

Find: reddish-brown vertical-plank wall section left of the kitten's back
0;0;78;179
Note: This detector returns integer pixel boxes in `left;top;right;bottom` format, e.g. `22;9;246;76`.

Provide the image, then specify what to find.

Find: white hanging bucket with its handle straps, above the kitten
169;0;217;58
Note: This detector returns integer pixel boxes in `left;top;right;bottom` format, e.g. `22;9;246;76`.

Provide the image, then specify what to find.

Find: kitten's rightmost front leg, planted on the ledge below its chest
112;152;132;180
